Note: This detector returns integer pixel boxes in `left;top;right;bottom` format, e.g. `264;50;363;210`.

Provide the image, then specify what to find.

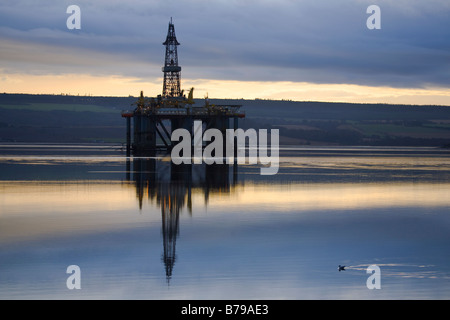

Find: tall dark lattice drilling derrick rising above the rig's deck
162;18;181;98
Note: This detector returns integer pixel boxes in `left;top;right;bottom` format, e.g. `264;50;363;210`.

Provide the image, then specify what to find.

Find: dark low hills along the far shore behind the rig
0;93;450;148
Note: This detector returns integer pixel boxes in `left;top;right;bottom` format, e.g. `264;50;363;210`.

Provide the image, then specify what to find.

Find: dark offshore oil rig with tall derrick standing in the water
122;18;245;156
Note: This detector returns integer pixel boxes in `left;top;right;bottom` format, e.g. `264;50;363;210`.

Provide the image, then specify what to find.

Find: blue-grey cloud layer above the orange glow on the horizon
0;0;450;87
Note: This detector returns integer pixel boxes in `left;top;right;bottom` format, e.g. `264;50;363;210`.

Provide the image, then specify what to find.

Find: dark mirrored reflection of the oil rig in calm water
127;157;237;283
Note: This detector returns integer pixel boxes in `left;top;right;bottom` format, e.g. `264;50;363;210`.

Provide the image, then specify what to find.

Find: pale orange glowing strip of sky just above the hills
0;74;450;106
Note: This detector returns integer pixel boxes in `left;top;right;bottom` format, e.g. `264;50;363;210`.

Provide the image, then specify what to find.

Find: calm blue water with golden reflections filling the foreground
0;144;450;300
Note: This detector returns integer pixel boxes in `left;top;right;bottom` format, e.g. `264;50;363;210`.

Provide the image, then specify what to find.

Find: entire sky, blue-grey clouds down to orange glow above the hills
0;0;450;105
